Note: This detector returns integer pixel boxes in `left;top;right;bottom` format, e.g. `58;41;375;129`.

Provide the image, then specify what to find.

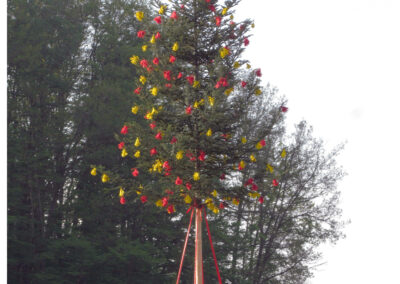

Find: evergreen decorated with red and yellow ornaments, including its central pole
91;0;287;283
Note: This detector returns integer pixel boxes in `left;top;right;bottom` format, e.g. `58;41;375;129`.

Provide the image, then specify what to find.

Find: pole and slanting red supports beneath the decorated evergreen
176;205;222;284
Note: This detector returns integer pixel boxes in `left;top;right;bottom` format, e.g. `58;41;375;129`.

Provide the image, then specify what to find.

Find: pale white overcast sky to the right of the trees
237;0;400;284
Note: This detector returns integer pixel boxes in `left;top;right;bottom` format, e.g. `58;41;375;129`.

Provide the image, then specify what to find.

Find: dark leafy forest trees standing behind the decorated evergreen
7;0;343;284
